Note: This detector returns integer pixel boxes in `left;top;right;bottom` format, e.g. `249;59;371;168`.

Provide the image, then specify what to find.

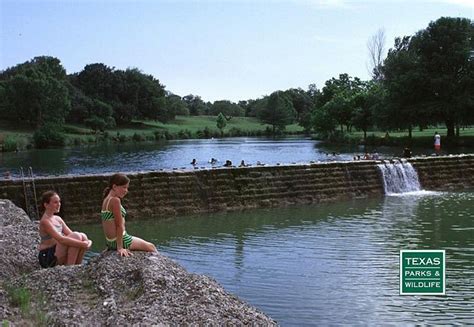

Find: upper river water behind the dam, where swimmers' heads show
0;137;465;176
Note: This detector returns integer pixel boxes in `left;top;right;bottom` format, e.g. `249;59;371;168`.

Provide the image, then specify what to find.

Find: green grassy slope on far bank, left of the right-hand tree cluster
0;116;303;151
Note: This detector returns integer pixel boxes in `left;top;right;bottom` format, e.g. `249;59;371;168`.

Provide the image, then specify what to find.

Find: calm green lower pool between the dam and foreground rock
74;192;474;326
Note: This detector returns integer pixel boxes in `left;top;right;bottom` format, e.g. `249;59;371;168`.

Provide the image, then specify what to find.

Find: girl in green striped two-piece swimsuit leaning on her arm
100;174;156;257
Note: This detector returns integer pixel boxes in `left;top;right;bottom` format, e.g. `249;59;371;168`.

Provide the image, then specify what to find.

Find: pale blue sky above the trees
0;0;474;101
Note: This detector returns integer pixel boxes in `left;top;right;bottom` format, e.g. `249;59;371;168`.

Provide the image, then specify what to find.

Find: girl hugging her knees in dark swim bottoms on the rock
38;191;92;268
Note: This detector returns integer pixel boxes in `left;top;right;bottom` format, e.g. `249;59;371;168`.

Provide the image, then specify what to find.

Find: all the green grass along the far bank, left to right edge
0;116;474;151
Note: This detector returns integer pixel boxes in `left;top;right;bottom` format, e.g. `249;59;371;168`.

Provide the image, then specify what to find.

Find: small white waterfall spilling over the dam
377;161;421;194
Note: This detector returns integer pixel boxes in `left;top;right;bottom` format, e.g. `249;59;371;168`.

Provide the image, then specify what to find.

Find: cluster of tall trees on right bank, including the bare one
311;17;474;138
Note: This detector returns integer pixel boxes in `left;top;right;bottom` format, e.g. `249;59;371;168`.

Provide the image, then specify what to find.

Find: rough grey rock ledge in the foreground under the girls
0;200;276;326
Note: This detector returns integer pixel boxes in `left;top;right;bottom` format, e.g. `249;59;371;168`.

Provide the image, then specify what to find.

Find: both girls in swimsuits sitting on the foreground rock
38;174;156;268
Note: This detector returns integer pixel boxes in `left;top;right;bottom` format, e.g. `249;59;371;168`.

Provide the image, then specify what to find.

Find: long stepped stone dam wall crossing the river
0;155;474;223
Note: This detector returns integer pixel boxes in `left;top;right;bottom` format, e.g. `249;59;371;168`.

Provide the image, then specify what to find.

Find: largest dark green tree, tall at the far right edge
413;17;474;137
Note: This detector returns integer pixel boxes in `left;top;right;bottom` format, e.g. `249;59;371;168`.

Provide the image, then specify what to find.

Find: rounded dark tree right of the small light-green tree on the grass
257;91;296;135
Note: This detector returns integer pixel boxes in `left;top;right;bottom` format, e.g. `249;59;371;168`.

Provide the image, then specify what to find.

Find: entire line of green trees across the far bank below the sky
0;17;474;142
